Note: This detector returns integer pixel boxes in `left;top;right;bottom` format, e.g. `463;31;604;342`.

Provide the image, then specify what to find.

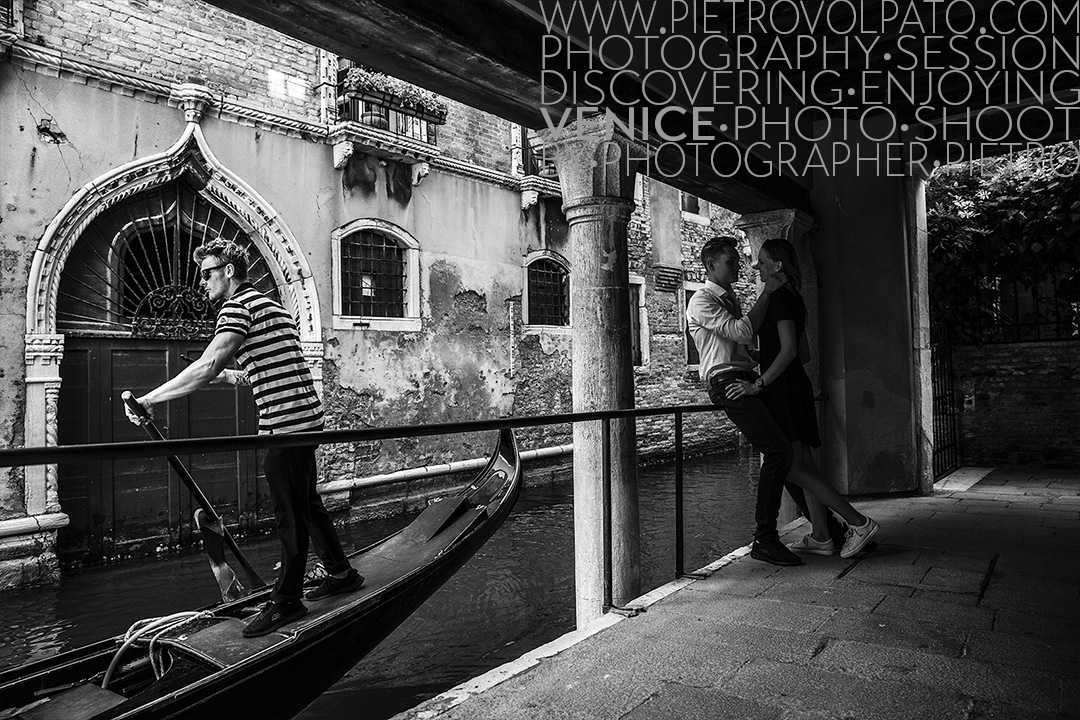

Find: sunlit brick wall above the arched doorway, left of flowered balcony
24;0;320;120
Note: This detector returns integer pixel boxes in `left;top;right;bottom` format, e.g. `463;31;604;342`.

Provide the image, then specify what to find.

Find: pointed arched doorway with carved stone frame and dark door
24;110;323;559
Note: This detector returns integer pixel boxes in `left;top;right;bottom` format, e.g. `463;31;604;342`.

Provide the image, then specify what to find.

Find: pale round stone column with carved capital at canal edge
544;117;645;627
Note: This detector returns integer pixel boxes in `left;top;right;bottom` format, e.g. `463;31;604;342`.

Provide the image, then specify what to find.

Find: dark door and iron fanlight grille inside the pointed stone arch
56;179;279;561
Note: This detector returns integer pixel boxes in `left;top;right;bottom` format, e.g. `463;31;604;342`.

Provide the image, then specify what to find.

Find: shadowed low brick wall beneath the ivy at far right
953;342;1080;467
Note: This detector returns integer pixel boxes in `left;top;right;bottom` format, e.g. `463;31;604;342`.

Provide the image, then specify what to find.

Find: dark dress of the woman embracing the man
757;287;821;448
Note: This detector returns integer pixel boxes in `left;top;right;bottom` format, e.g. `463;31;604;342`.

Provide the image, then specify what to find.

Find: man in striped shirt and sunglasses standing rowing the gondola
126;239;364;638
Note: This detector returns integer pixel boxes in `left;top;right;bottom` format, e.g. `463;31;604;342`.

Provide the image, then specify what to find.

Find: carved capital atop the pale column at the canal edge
540;114;649;208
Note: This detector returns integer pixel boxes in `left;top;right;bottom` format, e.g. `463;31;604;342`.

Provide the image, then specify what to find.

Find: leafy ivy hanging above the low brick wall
927;144;1080;343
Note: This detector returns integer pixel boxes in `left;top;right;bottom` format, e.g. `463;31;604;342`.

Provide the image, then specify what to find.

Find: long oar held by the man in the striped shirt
121;390;266;600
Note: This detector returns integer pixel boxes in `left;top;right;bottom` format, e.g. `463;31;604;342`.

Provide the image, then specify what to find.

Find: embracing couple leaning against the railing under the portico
686;236;878;566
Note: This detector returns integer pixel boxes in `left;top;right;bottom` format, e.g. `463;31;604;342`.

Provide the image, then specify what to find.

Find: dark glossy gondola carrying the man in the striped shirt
0;430;522;720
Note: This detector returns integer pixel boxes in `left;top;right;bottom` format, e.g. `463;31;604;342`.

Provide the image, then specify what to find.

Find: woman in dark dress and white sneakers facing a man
754;239;878;557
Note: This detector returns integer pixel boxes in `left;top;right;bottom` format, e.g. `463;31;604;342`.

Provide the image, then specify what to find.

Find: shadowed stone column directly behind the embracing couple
735;208;821;527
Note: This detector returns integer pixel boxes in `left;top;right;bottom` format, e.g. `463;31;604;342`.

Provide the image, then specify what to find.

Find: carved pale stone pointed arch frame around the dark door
24;98;323;525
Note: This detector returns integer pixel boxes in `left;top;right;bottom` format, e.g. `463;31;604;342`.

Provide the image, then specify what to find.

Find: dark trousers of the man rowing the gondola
262;446;349;602
